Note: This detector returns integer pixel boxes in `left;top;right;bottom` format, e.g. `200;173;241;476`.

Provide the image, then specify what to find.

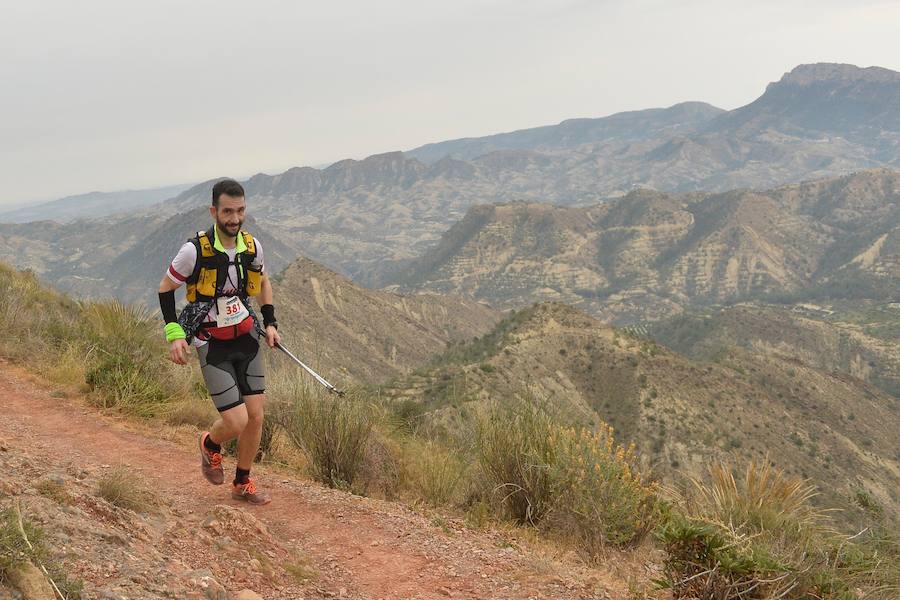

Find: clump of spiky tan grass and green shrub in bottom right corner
658;462;897;600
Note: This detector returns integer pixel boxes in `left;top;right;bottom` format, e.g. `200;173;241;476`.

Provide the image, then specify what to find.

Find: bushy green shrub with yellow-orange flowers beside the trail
475;402;656;558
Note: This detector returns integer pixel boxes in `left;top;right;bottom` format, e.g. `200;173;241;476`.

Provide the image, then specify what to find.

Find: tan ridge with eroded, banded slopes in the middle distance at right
395;170;900;323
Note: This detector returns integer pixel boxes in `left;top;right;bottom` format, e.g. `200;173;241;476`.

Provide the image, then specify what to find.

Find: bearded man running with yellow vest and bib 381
159;179;281;504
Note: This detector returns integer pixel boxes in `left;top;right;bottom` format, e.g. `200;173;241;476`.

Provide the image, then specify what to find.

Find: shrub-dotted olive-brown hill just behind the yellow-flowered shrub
386;303;900;524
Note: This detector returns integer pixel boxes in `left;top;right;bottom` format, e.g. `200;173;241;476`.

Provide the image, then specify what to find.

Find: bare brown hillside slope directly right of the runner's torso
274;258;500;385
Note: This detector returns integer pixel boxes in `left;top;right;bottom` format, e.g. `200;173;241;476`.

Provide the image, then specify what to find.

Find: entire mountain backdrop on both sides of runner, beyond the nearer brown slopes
7;64;900;323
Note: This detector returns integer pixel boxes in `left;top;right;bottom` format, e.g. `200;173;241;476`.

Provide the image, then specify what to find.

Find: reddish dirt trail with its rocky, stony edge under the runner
0;363;653;600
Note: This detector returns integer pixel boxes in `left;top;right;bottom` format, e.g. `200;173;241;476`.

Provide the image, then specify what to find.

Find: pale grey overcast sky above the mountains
0;0;900;204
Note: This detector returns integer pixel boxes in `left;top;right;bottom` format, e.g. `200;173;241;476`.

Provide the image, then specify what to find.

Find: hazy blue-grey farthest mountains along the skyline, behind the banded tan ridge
156;64;900;286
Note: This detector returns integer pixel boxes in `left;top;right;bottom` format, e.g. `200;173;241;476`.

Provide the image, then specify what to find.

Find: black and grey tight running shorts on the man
197;330;266;412
